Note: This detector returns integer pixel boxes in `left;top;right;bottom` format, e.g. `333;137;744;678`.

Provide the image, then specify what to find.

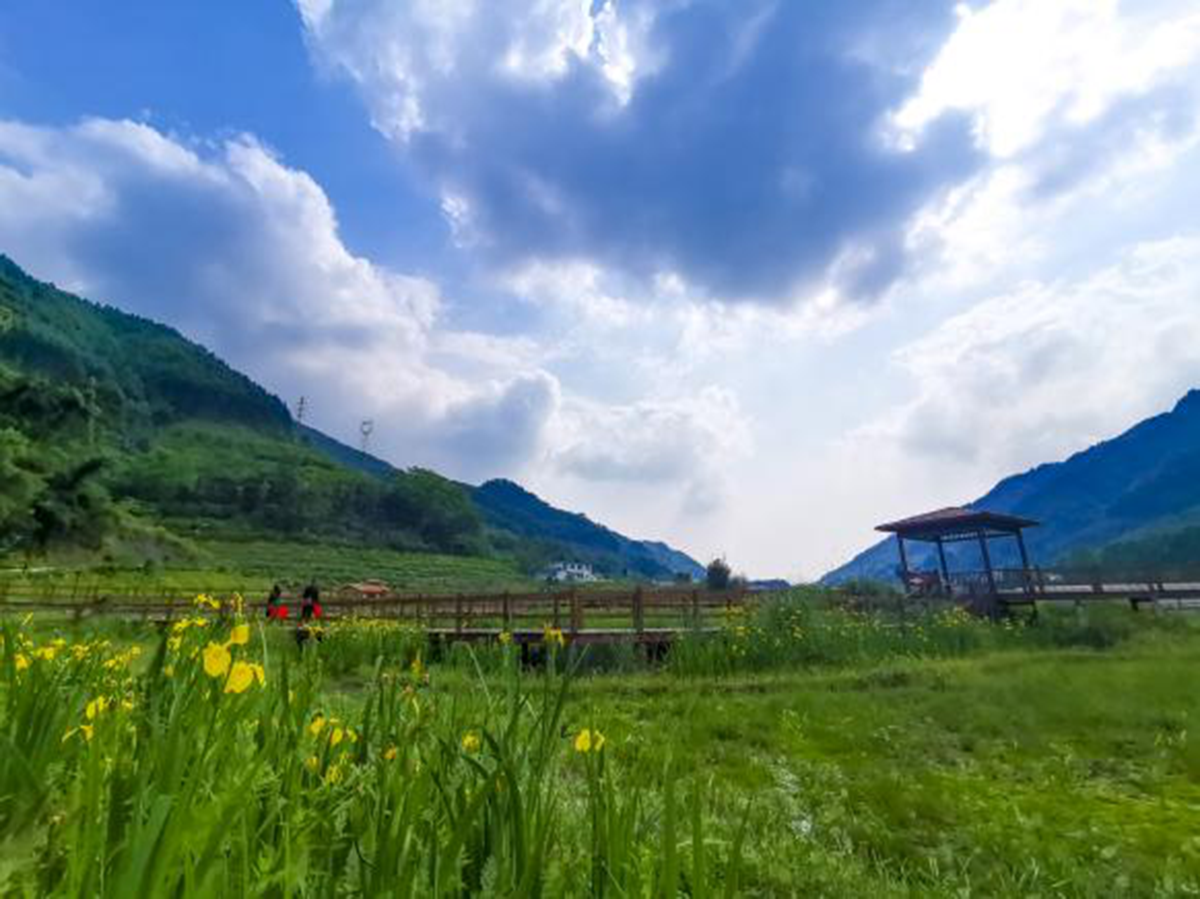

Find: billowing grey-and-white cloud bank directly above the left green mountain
0;119;558;477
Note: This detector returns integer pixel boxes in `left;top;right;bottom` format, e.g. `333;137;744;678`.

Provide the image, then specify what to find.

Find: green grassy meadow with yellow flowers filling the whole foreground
0;594;1200;897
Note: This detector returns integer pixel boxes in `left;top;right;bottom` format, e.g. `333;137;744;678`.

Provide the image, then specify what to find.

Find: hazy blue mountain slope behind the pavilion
824;390;1200;583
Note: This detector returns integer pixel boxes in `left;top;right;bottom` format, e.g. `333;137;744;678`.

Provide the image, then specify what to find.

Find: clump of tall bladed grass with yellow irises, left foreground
0;607;737;897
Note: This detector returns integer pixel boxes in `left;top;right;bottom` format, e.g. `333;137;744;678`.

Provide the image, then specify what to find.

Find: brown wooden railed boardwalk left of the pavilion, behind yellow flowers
0;587;751;645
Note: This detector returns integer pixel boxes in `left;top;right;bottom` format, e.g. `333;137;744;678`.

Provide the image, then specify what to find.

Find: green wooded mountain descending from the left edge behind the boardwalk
0;256;698;576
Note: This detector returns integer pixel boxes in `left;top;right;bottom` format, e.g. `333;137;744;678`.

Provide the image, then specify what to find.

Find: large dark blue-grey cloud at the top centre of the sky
299;0;979;302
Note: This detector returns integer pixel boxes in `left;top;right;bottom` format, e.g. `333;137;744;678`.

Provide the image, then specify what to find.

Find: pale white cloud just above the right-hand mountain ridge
857;235;1200;477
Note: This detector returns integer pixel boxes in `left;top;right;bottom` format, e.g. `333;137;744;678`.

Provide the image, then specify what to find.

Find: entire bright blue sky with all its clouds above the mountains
0;0;1200;580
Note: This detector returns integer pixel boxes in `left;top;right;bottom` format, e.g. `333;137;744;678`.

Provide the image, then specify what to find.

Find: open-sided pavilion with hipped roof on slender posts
875;508;1038;597
